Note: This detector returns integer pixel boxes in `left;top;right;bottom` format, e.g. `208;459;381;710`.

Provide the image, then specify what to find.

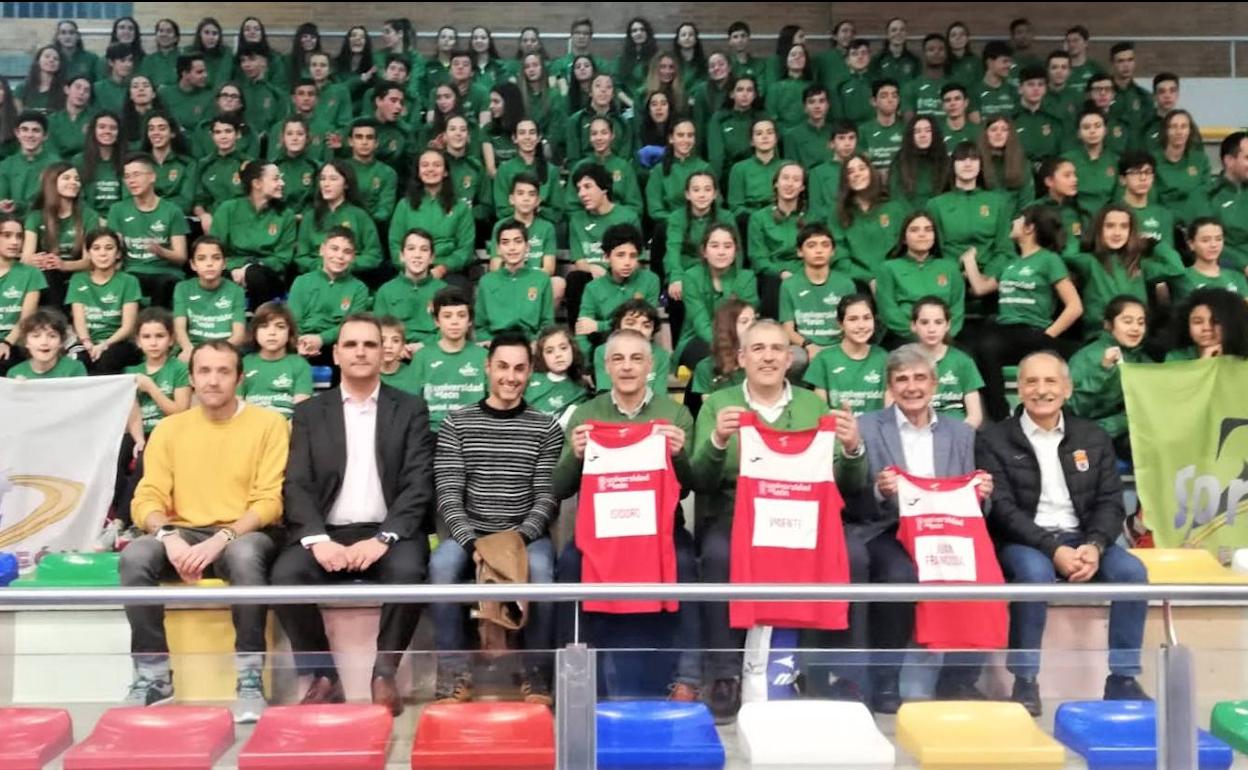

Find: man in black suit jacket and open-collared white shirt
272;313;433;715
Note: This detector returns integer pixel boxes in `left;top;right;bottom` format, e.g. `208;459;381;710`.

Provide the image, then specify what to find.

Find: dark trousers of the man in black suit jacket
272;524;429;679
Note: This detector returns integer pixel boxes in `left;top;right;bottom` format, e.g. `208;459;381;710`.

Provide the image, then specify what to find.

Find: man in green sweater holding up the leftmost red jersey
554;329;701;701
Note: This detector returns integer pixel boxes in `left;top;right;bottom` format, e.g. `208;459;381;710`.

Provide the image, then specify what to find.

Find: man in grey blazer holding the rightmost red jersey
846;344;992;714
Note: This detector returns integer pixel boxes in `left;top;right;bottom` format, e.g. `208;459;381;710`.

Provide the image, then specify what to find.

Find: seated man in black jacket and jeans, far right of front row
976;353;1148;716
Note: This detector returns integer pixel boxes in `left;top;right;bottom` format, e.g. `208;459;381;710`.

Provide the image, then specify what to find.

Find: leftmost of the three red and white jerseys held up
575;421;680;613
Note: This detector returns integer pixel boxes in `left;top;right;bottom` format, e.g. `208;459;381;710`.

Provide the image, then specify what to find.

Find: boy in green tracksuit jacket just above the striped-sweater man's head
474;220;554;342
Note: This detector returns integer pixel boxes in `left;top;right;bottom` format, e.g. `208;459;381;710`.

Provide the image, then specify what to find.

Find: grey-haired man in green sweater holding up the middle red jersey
690;321;867;723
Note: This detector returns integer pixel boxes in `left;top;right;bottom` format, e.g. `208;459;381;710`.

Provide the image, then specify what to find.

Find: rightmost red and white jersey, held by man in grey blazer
892;468;1010;649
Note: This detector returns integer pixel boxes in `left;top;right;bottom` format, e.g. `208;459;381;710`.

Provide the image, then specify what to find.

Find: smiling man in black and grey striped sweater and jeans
429;332;563;705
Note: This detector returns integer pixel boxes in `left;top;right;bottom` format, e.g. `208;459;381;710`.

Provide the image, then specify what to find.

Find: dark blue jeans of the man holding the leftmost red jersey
558;529;701;695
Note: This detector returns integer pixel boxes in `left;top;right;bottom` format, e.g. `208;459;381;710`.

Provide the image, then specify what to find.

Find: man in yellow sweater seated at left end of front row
121;339;290;723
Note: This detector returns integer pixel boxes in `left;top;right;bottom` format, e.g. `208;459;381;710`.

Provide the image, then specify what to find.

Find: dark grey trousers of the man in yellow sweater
119;527;277;658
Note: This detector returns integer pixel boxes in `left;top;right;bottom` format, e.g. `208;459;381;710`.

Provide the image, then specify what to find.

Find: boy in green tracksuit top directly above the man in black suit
288;227;369;357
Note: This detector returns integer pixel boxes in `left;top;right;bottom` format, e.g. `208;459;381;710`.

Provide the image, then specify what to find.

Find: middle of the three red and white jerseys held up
729;412;850;630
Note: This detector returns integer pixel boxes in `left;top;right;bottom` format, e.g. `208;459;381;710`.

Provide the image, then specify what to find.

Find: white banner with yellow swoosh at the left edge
0;376;135;568
